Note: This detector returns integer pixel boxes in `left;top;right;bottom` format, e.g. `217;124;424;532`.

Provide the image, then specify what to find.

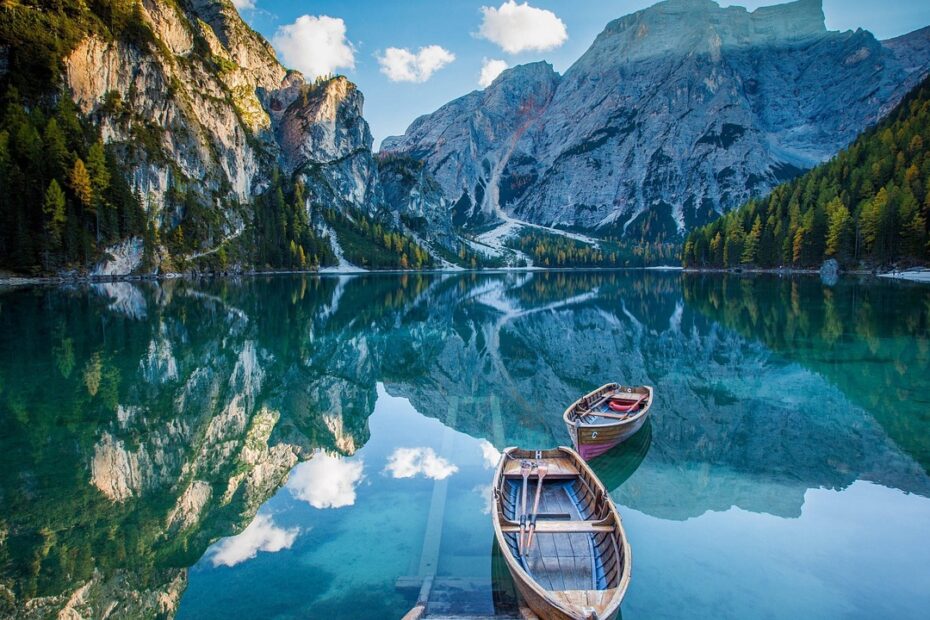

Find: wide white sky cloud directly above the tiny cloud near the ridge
478;0;568;54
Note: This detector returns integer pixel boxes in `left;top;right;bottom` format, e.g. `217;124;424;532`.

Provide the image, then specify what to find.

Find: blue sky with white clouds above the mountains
233;0;930;148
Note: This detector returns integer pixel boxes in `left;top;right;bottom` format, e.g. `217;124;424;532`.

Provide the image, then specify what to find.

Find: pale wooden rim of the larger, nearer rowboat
491;446;633;618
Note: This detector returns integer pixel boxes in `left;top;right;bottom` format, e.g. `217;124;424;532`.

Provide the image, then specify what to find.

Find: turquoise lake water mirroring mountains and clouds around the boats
0;272;930;619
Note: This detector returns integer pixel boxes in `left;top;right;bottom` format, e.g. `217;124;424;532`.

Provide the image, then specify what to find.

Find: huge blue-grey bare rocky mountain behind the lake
382;0;930;239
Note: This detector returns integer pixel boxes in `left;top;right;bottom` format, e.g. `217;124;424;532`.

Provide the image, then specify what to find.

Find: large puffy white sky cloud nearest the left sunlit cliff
271;15;355;79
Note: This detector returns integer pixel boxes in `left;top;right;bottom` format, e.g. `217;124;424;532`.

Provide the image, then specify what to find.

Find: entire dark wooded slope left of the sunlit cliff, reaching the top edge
0;0;152;270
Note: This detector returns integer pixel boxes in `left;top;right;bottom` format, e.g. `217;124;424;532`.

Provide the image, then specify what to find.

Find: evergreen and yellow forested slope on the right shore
682;78;930;268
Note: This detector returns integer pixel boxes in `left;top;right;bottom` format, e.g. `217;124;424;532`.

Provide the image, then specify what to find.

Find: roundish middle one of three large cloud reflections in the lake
287;452;363;508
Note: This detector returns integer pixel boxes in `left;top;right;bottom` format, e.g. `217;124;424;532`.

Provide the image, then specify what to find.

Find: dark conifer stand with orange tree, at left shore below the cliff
0;88;145;271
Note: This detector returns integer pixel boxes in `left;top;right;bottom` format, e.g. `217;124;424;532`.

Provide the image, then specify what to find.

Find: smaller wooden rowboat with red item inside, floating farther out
562;383;652;461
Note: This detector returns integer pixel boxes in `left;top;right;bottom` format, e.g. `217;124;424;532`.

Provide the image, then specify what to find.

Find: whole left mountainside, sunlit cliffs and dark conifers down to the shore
0;0;463;275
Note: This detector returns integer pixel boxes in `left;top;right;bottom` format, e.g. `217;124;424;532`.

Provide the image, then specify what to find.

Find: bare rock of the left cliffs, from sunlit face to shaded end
0;0;455;274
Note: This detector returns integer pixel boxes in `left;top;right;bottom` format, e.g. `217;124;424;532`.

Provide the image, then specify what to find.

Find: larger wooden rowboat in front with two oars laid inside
492;448;631;620
